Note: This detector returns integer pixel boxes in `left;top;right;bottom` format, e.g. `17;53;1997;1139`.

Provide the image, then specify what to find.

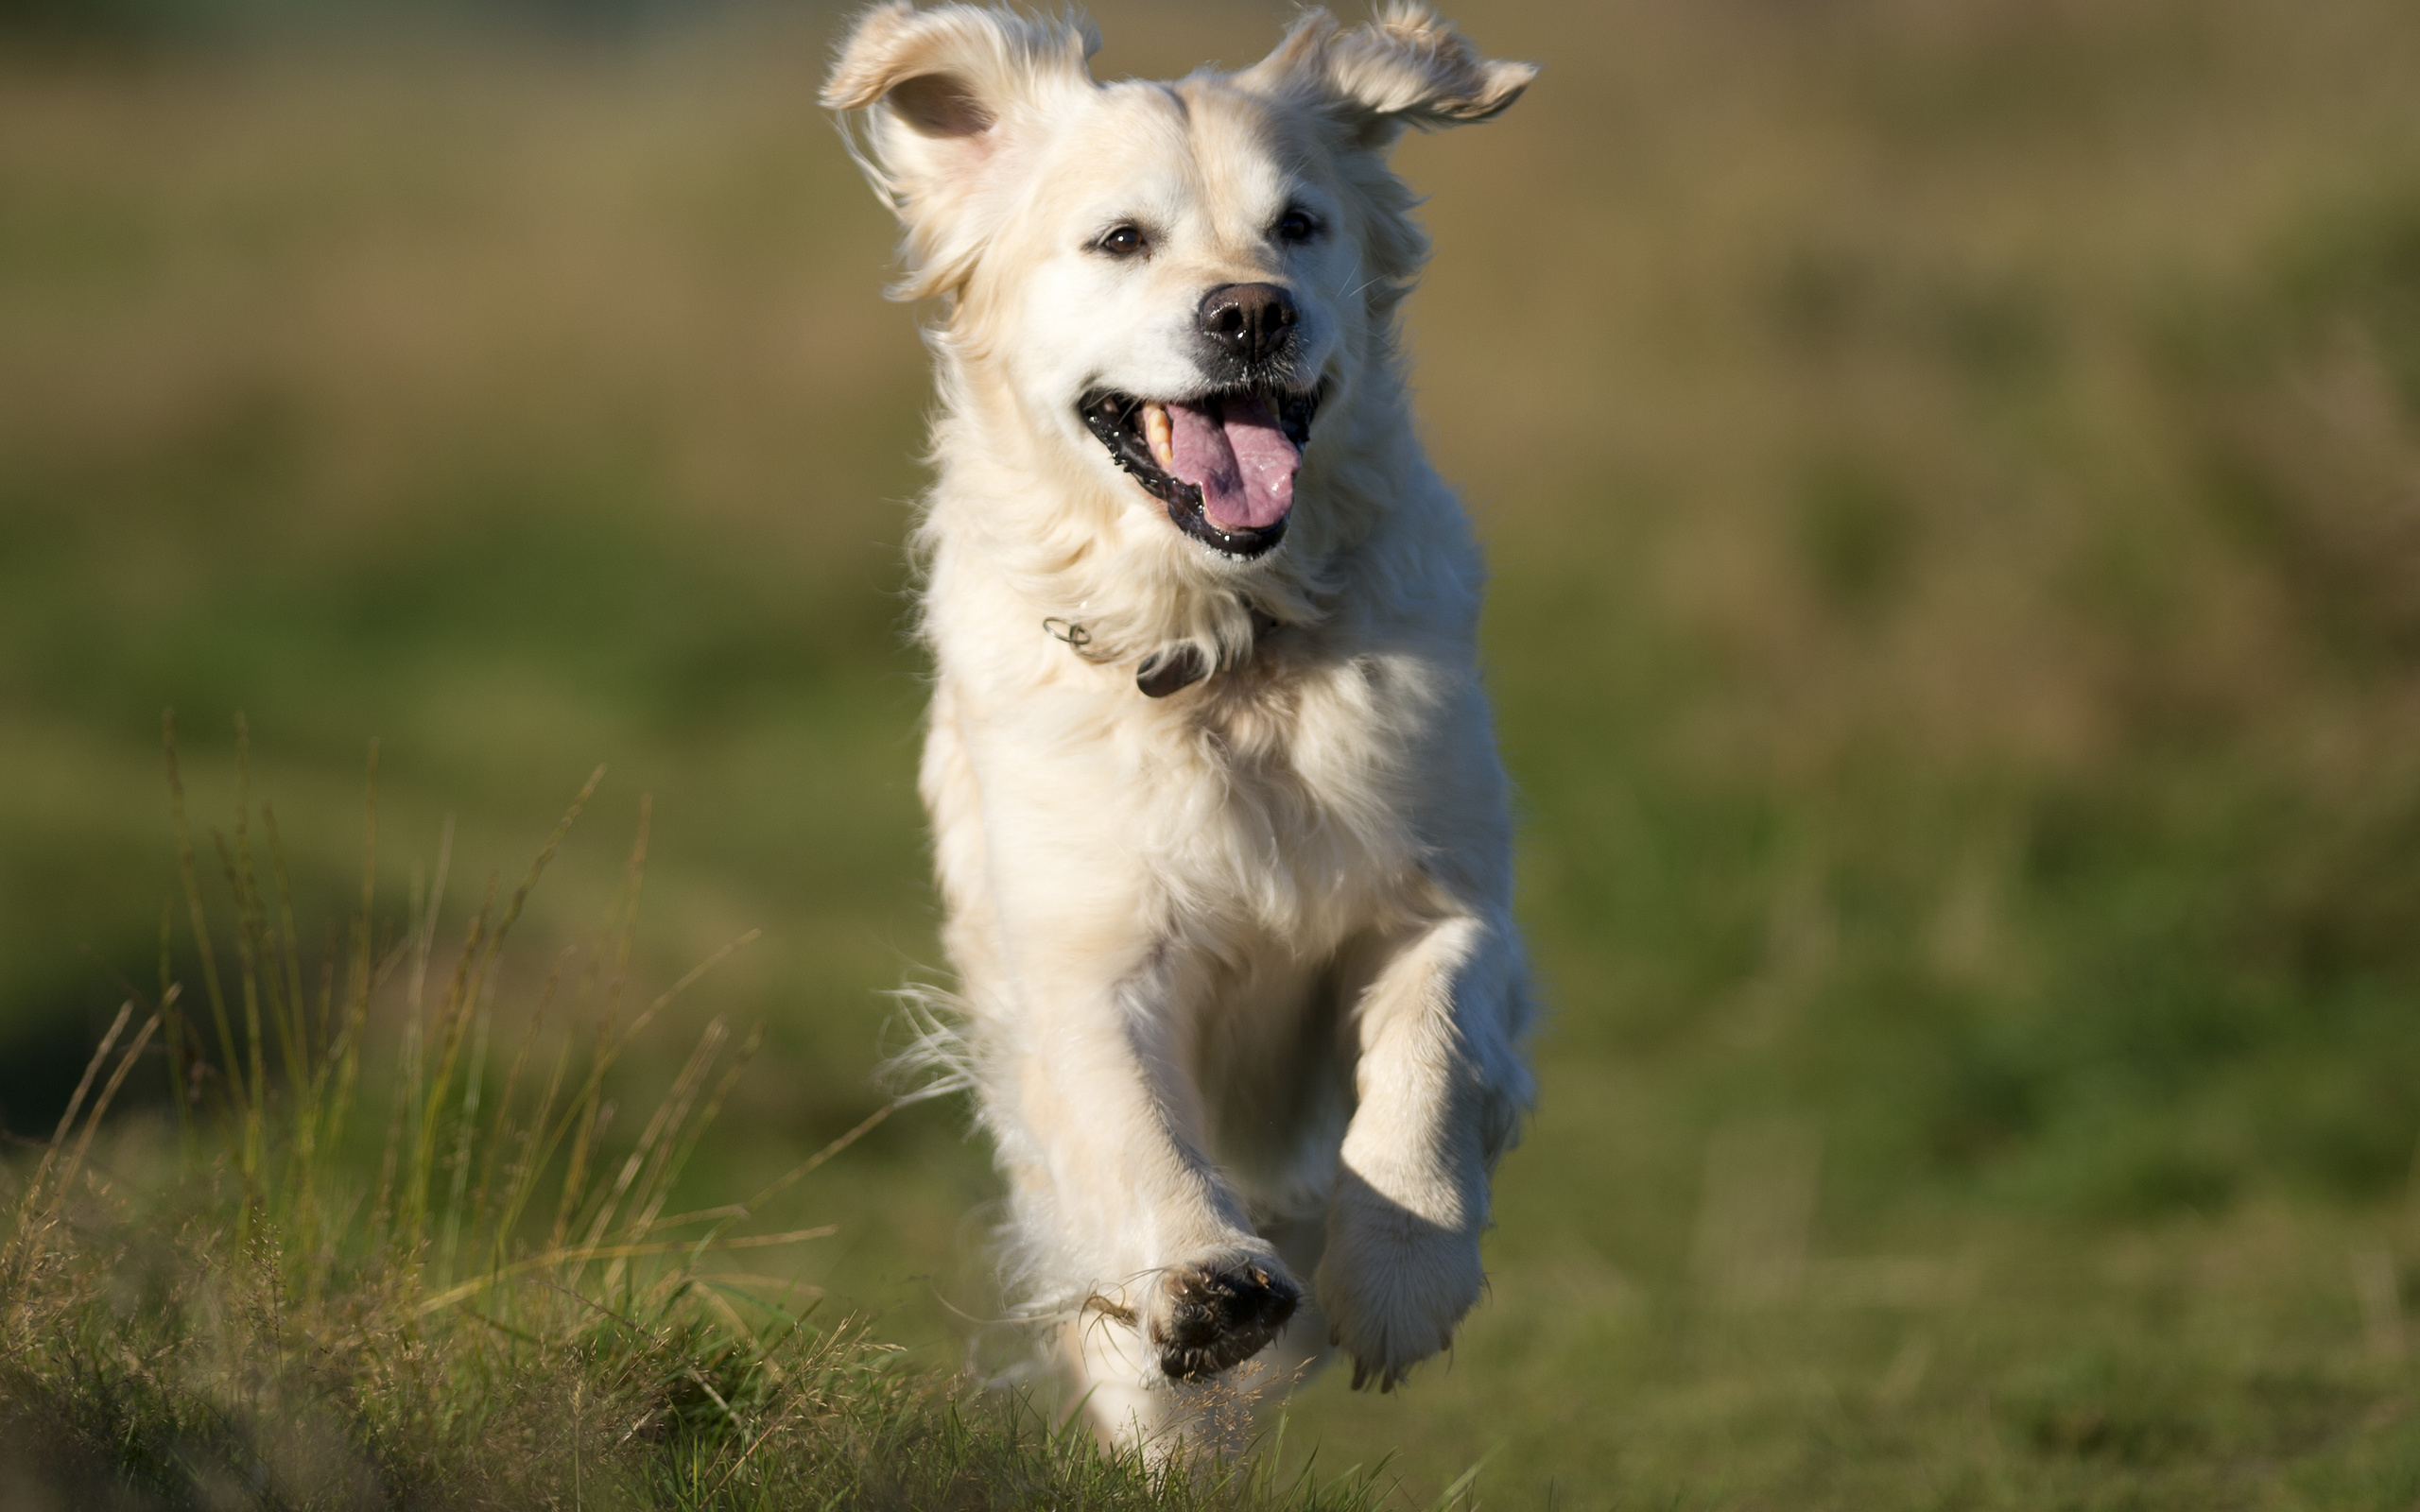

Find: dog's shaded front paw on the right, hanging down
1319;1180;1488;1391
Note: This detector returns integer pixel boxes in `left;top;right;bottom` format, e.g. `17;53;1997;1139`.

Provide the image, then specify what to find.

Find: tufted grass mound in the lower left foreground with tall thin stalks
0;745;1413;1512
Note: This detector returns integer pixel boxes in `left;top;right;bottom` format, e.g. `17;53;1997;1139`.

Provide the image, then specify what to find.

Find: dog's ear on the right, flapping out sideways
1236;0;1537;152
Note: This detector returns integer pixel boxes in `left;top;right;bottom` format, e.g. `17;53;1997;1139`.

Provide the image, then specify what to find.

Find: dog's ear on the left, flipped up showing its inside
822;0;1101;300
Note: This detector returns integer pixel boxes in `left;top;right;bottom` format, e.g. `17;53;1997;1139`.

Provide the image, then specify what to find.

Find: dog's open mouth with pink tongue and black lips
1077;387;1319;557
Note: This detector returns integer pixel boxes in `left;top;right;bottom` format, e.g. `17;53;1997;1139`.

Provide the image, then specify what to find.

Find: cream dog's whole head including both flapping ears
822;0;1537;558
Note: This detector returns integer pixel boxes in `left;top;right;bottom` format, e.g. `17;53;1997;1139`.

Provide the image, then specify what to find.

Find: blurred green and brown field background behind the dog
14;0;2420;1507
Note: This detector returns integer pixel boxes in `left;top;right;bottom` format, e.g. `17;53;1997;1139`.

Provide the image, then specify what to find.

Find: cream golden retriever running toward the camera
822;0;1537;1442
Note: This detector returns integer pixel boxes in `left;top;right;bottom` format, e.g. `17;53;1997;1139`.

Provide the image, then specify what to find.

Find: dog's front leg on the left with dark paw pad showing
1011;951;1302;1402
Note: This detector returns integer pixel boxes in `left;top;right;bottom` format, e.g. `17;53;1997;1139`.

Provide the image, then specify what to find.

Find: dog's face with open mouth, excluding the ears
996;79;1367;557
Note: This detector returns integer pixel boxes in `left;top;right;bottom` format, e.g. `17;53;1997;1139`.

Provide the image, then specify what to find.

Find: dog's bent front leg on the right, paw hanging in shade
1319;917;1530;1391
